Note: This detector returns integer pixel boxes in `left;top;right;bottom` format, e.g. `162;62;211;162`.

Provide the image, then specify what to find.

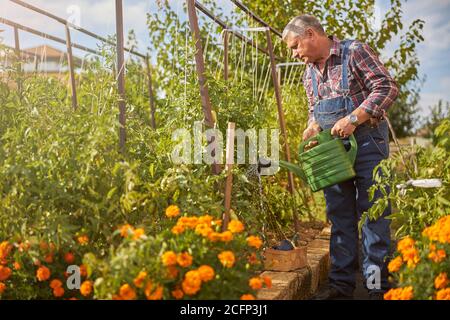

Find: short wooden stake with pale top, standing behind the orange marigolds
222;122;235;231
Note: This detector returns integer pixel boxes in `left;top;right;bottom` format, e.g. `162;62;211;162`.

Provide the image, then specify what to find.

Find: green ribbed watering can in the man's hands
279;129;358;192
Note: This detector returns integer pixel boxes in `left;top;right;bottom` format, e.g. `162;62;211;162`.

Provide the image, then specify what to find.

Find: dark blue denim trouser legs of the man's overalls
324;121;391;295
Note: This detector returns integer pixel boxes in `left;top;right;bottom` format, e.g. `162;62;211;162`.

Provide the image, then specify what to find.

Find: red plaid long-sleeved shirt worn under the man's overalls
303;36;399;124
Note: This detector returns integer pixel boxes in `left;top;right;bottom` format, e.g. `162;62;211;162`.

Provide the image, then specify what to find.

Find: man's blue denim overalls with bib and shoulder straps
310;40;391;295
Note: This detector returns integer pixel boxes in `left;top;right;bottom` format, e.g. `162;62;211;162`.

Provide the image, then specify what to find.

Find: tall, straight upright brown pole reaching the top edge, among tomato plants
116;0;126;152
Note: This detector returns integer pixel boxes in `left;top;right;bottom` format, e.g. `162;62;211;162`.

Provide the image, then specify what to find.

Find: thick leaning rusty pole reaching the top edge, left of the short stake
186;0;220;174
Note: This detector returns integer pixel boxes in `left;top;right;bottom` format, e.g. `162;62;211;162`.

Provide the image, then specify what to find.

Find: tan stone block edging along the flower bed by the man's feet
257;227;331;300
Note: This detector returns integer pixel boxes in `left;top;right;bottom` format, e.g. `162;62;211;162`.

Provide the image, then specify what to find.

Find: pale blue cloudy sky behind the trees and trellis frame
0;0;450;120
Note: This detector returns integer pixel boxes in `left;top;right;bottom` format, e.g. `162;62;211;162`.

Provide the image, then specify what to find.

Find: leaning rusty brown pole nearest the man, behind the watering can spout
266;29;300;233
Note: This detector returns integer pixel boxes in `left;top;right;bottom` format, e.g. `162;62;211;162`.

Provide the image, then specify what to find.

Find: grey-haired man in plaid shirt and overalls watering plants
283;15;398;299
